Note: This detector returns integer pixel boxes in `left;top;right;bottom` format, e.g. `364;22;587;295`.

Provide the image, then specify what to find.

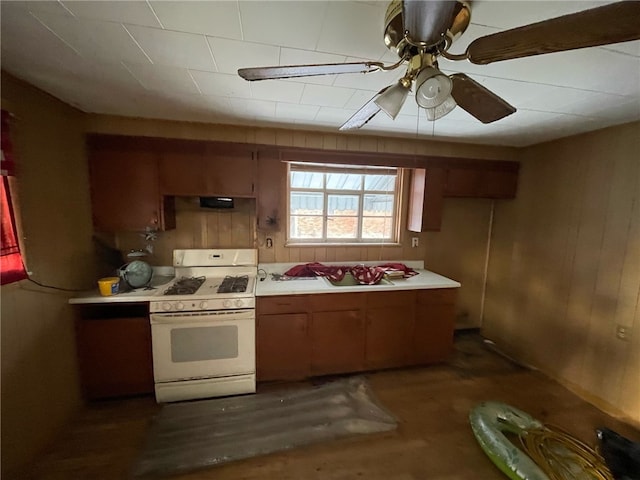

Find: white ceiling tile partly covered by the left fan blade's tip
207;37;280;74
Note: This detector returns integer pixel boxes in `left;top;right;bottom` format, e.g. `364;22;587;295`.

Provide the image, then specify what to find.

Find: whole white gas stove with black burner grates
149;249;258;402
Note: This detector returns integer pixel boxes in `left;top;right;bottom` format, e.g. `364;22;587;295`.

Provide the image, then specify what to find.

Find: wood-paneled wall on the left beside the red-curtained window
1;72;96;478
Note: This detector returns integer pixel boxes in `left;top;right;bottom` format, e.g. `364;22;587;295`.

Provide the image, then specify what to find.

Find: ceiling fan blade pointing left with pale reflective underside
238;62;383;81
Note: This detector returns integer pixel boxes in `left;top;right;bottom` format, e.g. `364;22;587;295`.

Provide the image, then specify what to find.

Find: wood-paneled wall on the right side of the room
483;123;640;424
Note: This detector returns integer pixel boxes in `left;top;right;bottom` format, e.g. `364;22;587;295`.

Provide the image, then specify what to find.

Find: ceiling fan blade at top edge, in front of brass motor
402;0;457;46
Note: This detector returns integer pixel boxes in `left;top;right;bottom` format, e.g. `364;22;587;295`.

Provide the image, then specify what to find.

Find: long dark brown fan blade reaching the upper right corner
467;1;640;65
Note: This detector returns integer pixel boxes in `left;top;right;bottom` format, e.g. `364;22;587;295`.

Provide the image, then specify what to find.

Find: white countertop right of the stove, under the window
256;261;461;297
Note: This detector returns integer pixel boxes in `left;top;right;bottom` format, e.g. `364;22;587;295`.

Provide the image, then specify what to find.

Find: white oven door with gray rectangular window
151;310;256;383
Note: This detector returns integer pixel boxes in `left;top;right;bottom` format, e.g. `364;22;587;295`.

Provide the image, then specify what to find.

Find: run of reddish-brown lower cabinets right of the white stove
256;289;456;381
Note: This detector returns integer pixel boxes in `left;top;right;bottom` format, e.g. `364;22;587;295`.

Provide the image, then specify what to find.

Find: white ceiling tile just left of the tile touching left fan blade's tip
126;25;216;72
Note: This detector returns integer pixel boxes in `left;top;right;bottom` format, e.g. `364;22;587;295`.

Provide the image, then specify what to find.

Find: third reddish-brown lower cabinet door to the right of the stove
366;305;414;368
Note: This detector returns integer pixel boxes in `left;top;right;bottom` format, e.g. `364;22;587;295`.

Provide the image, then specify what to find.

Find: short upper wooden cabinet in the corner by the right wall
444;163;518;198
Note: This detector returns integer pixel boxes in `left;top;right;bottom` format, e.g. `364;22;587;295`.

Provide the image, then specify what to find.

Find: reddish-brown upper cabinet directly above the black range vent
159;140;257;197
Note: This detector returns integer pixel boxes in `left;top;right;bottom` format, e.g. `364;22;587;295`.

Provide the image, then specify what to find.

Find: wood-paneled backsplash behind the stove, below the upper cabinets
114;197;257;265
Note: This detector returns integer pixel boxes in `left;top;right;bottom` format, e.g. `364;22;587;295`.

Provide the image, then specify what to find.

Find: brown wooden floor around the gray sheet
19;334;640;480
